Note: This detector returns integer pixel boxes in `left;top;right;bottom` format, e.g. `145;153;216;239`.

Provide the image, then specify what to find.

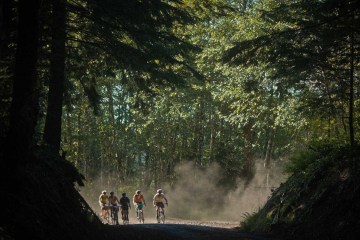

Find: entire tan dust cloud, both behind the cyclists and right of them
80;161;285;222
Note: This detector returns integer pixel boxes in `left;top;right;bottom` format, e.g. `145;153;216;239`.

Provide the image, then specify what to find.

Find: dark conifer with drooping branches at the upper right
224;0;359;145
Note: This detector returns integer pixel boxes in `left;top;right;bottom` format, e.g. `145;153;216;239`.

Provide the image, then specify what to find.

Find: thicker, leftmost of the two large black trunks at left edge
2;0;39;171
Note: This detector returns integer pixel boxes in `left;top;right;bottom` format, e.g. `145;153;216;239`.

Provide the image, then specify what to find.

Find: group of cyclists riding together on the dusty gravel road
99;189;168;224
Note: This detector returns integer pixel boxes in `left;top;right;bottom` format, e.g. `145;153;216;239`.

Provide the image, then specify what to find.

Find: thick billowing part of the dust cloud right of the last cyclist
165;162;284;221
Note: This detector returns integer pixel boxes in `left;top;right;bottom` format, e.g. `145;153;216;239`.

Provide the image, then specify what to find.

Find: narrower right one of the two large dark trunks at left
44;0;66;152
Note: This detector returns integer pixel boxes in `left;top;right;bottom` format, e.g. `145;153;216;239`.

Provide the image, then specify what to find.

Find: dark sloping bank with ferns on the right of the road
241;142;360;239
